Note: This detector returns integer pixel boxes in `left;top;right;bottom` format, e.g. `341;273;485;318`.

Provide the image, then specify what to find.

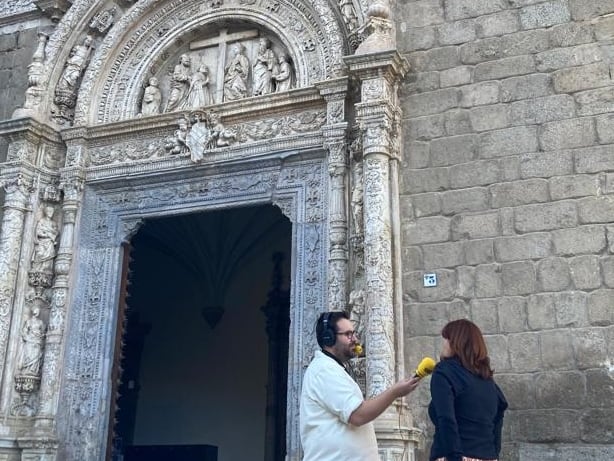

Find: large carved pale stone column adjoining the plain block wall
344;48;422;461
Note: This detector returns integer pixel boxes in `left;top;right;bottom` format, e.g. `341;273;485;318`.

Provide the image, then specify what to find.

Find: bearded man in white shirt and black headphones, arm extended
299;311;420;461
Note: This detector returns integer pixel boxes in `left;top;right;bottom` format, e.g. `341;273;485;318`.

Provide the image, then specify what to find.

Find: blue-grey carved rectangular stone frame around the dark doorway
54;157;327;461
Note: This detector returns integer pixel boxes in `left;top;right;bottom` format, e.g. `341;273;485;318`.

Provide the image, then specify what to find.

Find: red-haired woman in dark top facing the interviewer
429;319;507;461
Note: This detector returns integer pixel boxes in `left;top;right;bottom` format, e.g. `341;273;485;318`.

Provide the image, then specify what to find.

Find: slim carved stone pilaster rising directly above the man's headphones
317;77;348;310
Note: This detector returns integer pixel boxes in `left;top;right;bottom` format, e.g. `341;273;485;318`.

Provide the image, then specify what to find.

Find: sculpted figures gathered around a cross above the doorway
144;29;295;116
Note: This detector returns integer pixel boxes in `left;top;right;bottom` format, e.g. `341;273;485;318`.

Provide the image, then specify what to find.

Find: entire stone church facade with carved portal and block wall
0;0;614;461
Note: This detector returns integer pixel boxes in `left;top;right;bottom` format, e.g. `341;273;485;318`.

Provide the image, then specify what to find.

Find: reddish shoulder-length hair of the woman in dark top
441;319;493;379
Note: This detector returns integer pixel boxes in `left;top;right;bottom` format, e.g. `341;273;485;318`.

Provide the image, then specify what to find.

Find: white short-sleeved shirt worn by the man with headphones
299;351;379;461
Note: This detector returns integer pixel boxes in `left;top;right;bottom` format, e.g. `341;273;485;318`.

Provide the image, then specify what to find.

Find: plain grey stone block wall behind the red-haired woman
394;0;614;461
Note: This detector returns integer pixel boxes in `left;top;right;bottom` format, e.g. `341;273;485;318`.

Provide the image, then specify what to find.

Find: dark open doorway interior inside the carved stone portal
107;205;292;461
